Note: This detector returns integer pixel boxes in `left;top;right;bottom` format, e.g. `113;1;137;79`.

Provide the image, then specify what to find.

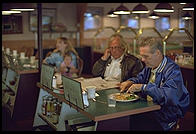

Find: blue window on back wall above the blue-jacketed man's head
155;16;170;32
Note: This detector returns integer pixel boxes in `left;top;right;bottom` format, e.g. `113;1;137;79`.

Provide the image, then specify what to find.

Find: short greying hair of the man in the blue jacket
139;37;163;54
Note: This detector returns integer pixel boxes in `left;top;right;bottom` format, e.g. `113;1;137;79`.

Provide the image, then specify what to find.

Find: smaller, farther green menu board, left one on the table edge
40;63;54;89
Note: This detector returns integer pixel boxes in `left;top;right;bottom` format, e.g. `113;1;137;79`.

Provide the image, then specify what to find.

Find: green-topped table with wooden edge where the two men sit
34;83;160;131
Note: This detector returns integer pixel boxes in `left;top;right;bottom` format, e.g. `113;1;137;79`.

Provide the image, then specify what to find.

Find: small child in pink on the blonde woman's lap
60;53;77;77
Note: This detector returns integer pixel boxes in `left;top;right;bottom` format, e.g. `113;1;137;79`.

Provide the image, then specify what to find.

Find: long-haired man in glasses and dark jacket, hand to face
92;34;143;82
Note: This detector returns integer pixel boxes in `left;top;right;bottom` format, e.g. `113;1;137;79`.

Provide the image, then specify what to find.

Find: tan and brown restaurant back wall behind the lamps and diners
2;3;194;54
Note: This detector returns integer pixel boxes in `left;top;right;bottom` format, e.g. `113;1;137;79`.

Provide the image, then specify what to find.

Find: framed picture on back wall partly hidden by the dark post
29;8;57;32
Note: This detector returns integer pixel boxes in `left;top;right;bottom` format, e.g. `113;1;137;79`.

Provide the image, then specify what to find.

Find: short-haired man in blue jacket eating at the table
120;38;190;131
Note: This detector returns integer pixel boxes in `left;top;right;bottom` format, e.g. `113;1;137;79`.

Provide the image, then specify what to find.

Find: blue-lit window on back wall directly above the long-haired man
120;14;140;29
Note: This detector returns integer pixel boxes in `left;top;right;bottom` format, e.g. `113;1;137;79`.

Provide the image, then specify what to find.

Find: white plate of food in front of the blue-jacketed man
110;93;139;102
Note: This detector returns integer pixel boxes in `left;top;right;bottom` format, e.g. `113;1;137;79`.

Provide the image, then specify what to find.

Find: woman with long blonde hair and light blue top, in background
43;37;78;72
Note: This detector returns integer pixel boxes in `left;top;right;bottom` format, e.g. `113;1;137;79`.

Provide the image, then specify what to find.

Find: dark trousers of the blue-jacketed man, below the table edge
130;112;163;131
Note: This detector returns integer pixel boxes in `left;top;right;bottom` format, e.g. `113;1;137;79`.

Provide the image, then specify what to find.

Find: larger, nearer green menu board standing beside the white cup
62;75;84;109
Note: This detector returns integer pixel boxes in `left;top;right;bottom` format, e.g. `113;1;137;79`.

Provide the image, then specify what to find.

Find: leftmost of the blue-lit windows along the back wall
84;7;103;31
